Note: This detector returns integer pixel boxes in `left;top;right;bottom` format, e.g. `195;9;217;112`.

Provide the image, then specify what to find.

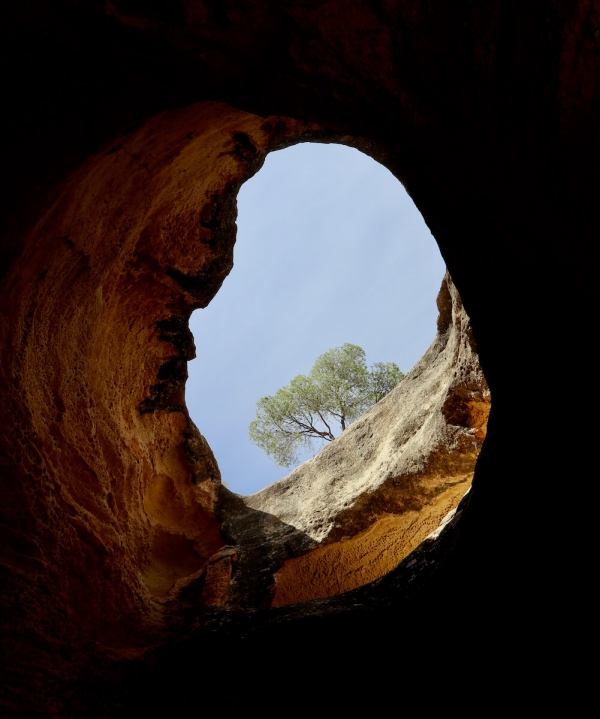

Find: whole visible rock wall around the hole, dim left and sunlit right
0;97;489;716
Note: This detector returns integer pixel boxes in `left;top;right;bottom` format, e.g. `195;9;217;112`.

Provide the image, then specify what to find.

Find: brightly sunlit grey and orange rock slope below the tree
221;274;490;607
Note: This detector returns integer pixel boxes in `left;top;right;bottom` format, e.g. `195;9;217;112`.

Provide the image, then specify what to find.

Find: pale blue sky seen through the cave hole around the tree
186;143;445;494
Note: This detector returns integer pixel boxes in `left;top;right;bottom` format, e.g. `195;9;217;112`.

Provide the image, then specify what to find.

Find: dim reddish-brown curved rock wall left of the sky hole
0;103;328;704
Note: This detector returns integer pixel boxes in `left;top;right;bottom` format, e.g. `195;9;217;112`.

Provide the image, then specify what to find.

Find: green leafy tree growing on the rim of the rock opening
249;343;404;467
